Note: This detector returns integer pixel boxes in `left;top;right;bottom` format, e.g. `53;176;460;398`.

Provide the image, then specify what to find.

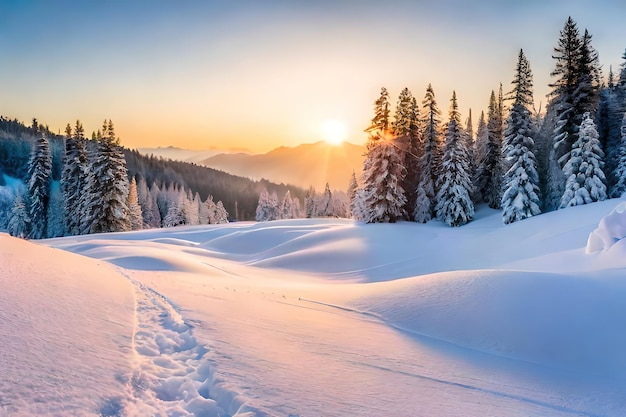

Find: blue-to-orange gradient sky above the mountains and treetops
0;0;626;152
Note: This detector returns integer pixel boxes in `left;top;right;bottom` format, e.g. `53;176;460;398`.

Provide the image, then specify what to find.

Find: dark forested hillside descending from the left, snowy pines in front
0;116;305;238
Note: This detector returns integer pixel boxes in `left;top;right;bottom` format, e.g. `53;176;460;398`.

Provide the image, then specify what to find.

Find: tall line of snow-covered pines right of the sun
348;17;626;226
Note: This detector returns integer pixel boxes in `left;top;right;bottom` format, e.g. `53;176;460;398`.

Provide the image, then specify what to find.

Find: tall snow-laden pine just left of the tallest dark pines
502;50;541;224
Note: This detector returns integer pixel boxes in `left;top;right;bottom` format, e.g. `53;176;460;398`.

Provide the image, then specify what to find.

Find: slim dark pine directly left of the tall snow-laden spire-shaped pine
475;91;502;208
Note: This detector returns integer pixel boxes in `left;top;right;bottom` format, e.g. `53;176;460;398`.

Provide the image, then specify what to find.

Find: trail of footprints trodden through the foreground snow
118;269;264;417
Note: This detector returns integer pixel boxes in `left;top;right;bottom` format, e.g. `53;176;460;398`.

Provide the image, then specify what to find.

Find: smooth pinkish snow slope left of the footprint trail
0;234;134;416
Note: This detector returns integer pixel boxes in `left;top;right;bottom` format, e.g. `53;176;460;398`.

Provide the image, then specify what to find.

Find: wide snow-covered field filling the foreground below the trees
0;200;626;417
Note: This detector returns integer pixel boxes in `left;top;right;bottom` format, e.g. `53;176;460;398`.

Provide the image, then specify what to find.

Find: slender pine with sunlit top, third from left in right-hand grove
412;84;443;223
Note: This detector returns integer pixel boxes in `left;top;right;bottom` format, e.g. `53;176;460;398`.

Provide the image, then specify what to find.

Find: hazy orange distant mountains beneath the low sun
139;141;365;191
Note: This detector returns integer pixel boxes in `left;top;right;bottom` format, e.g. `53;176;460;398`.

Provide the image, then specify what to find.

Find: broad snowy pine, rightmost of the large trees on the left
86;120;130;233
